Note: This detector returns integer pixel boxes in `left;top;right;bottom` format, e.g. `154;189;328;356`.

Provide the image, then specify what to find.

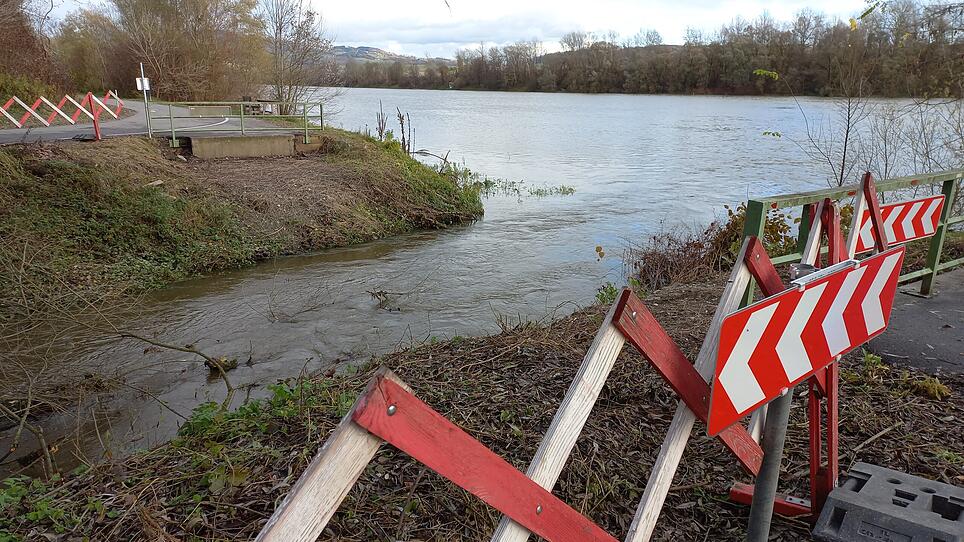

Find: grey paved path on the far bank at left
0;100;292;145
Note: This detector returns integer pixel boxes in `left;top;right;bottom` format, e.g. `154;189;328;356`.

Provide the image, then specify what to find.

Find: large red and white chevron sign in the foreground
708;247;904;436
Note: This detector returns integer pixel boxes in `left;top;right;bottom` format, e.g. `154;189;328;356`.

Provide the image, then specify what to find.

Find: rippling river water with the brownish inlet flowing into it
7;89;892;472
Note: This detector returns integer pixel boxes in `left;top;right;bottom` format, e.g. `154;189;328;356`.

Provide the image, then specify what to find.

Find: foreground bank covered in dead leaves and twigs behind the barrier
0;276;964;540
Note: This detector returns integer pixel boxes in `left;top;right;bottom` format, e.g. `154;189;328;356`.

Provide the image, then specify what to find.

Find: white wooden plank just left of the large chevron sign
626;238;762;542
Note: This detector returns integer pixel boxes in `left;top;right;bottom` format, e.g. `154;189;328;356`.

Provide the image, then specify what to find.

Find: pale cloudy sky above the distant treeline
58;0;866;57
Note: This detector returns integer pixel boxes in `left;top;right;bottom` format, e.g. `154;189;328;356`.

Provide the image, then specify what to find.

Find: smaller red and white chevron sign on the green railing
857;196;944;254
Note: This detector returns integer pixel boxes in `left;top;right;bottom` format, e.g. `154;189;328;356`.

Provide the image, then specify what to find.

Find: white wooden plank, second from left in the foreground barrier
492;304;629;542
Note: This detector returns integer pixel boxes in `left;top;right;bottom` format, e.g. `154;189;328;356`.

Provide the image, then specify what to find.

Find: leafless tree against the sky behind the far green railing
260;0;336;114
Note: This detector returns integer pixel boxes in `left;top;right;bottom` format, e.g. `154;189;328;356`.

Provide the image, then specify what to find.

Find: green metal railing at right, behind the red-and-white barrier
743;169;964;302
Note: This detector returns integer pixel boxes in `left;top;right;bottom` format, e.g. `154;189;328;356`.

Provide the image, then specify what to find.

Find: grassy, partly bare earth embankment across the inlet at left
0;130;482;298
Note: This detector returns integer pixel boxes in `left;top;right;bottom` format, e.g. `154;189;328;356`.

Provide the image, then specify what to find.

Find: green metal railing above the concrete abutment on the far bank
145;101;325;147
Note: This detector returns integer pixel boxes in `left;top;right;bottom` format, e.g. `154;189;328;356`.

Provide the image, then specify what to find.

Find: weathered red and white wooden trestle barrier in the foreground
258;174;928;542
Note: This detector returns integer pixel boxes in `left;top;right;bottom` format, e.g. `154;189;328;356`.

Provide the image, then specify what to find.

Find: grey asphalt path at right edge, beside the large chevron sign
868;269;964;374
